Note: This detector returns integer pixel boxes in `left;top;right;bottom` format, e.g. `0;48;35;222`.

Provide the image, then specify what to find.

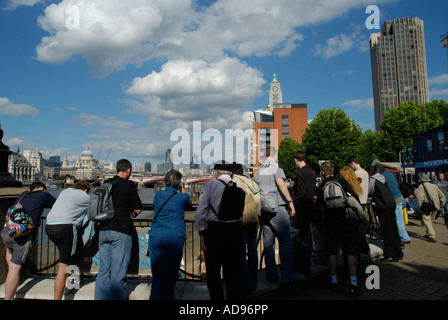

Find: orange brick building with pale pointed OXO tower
251;74;308;168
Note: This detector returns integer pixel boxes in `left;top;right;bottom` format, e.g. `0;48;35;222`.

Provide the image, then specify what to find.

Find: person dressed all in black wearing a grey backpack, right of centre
317;161;359;297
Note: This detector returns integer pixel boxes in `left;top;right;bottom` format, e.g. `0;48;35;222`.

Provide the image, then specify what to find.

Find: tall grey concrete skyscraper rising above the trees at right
370;17;429;131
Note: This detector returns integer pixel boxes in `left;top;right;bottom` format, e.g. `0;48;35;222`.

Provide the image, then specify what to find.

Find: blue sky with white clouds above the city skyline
0;0;448;170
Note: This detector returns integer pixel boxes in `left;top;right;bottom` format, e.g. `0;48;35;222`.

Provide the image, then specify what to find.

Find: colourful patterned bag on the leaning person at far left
5;193;35;239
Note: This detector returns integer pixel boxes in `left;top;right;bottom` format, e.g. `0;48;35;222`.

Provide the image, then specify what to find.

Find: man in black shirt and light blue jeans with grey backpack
95;159;142;300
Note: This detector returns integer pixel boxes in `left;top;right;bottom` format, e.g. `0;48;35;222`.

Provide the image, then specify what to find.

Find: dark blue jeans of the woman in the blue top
148;236;184;300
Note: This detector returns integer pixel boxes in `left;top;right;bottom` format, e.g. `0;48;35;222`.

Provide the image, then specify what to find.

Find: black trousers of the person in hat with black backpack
204;222;241;300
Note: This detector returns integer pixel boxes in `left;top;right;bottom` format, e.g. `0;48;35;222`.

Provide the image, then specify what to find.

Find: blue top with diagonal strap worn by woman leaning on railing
148;187;191;239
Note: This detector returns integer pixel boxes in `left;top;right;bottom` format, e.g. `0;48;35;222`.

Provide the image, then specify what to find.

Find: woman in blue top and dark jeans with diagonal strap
148;170;191;300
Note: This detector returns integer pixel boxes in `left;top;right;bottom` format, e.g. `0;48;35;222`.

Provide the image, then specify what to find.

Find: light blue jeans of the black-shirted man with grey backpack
95;230;132;300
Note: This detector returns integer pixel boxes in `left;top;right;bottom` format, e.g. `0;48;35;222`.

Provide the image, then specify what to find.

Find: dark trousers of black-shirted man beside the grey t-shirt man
290;226;311;277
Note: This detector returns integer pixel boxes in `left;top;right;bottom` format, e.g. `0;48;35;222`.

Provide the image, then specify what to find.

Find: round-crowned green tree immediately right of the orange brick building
302;108;362;172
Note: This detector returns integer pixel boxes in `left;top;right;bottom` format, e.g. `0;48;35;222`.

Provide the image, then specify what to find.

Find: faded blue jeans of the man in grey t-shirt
263;206;295;282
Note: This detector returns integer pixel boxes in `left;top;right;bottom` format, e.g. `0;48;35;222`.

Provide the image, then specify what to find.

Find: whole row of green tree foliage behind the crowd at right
279;100;448;178
